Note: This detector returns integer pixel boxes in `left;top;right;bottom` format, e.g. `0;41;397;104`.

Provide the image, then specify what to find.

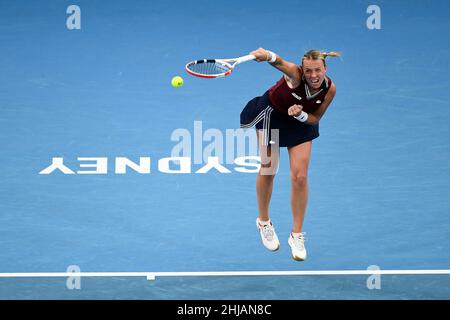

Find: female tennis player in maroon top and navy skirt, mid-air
241;48;339;261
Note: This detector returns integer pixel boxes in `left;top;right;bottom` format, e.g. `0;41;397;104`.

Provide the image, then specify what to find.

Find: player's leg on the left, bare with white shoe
256;130;280;251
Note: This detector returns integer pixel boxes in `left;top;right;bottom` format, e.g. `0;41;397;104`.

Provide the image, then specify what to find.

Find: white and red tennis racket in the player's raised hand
186;54;256;79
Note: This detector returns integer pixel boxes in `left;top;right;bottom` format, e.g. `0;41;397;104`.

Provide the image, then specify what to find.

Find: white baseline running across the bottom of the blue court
0;269;450;280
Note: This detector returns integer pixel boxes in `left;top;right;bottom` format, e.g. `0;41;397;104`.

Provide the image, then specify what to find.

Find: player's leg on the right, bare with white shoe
288;141;312;260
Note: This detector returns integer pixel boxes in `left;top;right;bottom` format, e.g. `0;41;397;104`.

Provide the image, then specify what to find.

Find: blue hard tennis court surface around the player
0;0;450;299
